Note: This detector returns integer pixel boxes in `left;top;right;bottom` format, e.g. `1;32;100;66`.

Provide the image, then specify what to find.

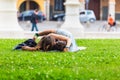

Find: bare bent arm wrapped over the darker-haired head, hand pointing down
48;33;71;51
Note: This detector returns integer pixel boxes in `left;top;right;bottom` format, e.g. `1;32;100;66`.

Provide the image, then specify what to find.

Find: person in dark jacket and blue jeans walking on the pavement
31;9;39;31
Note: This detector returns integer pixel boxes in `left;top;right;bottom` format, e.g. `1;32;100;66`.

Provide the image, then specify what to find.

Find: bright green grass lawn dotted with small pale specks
0;39;120;80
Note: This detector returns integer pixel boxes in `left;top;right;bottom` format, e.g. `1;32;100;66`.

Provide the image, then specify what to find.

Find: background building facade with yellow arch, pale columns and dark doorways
17;0;120;20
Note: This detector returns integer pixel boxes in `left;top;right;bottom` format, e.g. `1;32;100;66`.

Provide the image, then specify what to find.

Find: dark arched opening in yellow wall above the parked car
19;0;40;12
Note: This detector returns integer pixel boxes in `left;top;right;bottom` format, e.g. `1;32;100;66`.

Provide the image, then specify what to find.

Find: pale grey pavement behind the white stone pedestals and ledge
19;21;120;33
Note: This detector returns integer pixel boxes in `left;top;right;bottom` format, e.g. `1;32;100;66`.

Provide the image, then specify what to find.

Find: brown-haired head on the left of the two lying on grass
41;36;55;51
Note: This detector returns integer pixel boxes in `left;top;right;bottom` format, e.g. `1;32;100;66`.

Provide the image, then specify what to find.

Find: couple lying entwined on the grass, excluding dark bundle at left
22;29;85;52
